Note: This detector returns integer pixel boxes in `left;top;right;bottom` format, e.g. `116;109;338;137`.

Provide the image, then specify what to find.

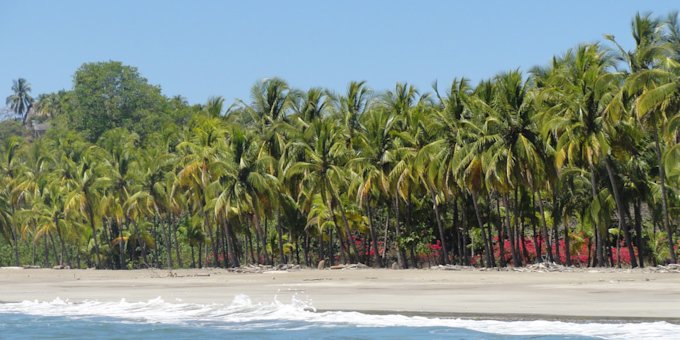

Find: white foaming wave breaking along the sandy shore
0;295;680;339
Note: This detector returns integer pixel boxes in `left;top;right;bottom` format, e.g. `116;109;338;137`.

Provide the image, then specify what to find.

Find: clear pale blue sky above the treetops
0;0;680;107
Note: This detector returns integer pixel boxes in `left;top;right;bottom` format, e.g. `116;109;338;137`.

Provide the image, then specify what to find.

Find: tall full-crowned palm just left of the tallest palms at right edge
538;44;623;266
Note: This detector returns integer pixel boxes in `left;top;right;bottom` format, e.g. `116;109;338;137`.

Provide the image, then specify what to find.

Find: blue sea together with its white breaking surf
0;295;680;340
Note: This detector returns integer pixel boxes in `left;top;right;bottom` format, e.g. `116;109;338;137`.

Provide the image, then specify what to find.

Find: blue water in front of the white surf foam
0;314;587;339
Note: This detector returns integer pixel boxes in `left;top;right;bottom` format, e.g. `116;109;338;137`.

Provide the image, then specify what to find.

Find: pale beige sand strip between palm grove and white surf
0;269;680;323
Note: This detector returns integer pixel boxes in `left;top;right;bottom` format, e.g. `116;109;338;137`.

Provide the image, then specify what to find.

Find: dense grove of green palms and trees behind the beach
0;13;680;269
